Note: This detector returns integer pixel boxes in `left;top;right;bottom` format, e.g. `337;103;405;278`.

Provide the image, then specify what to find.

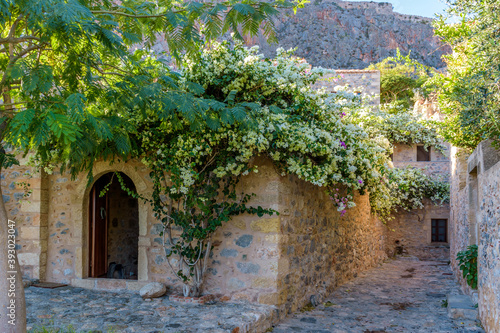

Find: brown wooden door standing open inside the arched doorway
89;175;109;277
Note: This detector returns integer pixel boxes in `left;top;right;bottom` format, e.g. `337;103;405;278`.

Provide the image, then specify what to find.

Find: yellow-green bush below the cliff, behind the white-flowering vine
367;49;436;112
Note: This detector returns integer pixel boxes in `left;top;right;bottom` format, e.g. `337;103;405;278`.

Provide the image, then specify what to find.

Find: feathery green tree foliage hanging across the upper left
0;0;292;175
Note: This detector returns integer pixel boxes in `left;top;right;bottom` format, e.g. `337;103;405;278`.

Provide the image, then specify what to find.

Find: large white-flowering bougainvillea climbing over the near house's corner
130;43;450;295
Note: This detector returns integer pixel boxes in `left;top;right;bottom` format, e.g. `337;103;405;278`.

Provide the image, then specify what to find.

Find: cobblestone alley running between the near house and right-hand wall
273;259;484;333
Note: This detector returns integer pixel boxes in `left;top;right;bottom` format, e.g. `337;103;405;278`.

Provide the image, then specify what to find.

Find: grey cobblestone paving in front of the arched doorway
26;287;275;333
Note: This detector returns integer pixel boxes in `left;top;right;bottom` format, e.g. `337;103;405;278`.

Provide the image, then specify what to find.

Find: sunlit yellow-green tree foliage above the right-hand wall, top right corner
432;0;500;149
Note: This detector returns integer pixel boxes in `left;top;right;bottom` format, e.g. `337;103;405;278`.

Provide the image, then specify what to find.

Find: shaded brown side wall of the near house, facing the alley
276;176;386;313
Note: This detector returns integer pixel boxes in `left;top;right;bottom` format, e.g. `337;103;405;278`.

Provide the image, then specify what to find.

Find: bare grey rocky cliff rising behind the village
247;0;451;69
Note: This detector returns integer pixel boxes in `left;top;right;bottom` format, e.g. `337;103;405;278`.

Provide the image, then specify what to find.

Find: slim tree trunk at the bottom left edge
0;175;26;333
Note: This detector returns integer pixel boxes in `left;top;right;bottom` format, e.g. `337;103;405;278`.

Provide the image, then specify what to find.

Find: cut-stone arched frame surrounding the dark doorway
72;162;149;284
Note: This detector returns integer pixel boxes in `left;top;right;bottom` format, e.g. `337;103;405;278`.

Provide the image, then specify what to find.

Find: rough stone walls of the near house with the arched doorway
6;158;386;315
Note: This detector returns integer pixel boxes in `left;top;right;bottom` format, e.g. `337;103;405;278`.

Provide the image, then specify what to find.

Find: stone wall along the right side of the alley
451;141;500;332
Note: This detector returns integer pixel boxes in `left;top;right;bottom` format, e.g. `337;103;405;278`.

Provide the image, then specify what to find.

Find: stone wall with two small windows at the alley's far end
386;144;450;260
